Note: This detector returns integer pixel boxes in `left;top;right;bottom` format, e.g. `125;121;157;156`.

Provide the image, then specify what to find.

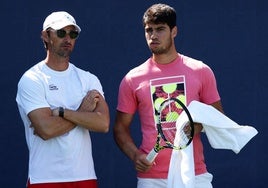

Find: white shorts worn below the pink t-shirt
137;172;213;188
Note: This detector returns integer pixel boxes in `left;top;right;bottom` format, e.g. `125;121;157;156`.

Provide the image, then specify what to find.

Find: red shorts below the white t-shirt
27;180;98;188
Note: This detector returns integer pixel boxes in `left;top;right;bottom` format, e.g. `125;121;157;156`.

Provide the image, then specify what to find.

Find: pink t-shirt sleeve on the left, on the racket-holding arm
117;76;137;114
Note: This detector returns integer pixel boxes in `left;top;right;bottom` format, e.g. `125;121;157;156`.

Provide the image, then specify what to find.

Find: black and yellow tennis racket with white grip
146;98;194;162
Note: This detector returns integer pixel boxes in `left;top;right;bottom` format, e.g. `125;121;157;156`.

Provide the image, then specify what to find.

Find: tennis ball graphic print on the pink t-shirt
150;76;186;132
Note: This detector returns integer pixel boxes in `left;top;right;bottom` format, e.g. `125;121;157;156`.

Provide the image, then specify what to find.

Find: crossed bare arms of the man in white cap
28;90;110;140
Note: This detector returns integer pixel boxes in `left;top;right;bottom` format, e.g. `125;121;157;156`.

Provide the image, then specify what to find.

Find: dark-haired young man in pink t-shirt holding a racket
114;4;222;188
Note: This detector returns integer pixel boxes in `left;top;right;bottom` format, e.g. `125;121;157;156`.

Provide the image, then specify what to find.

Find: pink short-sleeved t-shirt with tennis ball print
117;54;220;178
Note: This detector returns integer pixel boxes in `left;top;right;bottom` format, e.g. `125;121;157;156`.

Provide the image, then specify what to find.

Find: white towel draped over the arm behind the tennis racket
168;101;258;188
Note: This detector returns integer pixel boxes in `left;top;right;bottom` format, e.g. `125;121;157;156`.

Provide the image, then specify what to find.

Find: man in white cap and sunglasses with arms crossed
16;11;110;188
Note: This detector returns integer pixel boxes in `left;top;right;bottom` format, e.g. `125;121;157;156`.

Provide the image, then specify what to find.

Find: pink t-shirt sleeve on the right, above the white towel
200;64;220;104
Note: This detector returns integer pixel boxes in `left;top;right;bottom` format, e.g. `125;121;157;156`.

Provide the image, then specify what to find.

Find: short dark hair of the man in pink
142;4;177;29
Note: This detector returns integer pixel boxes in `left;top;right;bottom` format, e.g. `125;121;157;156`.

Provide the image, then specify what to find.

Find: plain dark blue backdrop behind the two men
0;0;268;188
